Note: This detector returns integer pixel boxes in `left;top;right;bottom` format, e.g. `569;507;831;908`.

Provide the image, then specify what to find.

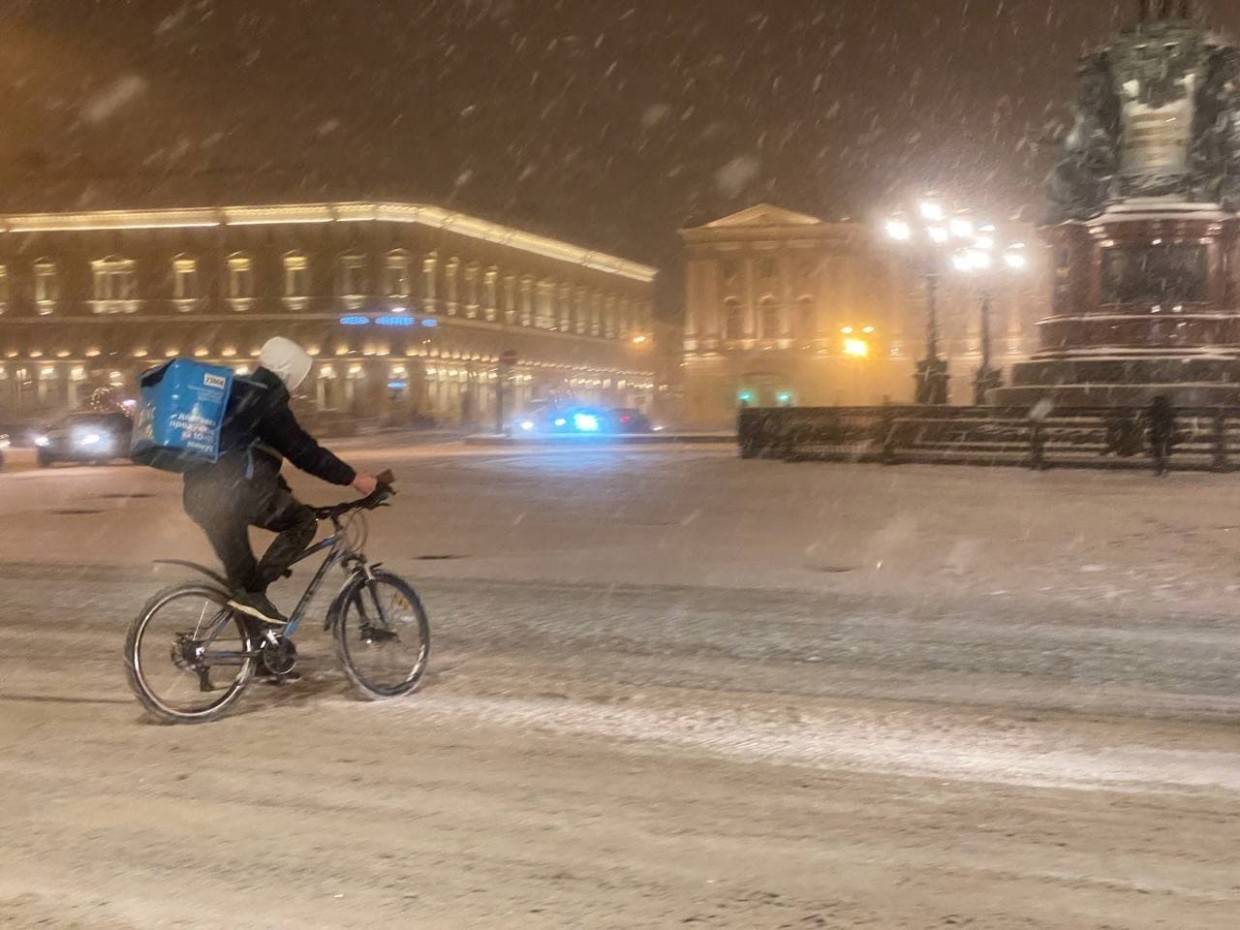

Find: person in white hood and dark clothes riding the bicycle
184;336;378;626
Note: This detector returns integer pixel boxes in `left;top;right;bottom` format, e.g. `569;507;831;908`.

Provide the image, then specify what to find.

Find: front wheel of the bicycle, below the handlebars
336;572;430;701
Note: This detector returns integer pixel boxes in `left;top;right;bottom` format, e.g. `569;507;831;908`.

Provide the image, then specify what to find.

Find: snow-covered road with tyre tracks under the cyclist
0;444;1240;930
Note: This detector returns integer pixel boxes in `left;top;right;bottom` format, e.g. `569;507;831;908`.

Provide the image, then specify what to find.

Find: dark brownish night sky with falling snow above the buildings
0;0;1240;311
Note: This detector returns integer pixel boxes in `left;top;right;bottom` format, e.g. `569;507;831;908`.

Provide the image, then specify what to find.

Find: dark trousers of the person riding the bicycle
185;479;319;591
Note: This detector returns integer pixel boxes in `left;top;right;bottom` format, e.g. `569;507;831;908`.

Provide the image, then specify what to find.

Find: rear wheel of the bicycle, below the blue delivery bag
125;584;254;723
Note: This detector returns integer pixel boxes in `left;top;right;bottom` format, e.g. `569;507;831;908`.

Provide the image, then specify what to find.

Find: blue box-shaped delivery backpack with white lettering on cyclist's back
129;358;233;471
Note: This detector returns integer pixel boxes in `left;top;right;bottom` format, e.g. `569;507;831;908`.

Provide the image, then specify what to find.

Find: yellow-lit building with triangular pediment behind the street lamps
681;205;1047;427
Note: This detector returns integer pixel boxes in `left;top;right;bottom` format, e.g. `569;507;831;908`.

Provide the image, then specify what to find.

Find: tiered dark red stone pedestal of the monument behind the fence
992;198;1240;407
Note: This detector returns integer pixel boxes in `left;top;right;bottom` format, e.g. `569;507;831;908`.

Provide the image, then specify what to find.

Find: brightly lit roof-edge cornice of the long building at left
0;201;657;284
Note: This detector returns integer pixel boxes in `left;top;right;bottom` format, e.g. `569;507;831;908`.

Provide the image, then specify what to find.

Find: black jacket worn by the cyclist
186;367;357;485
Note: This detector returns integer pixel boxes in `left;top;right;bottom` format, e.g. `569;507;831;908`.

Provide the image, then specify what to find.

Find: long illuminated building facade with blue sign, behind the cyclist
0;202;655;424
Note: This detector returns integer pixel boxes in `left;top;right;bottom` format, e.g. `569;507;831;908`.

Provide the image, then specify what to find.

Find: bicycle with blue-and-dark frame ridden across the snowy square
125;472;430;723
